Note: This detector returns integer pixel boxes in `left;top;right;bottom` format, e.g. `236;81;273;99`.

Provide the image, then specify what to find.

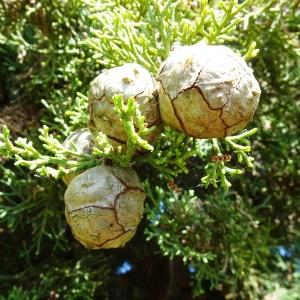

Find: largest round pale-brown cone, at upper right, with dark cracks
156;43;260;138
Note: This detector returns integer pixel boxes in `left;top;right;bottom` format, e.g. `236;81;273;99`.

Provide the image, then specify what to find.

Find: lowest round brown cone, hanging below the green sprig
64;166;145;249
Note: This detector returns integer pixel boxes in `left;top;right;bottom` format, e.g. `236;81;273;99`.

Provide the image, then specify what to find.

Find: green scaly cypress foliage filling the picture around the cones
0;0;300;300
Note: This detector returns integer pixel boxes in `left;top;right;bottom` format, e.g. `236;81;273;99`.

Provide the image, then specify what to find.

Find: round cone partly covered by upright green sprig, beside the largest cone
89;63;160;146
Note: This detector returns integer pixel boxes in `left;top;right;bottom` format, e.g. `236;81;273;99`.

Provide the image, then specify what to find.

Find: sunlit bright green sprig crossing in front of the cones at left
0;95;159;179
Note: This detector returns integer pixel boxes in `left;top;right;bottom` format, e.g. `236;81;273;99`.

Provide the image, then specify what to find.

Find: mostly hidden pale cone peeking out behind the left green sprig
62;128;92;185
